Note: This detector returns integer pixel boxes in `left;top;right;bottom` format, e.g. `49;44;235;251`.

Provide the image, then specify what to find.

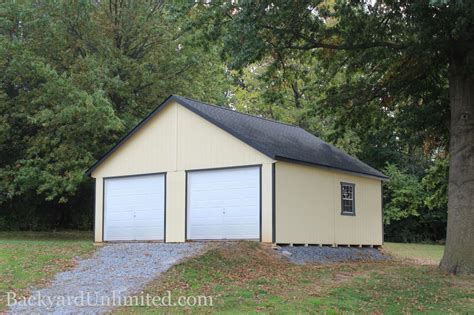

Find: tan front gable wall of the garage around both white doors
92;103;274;242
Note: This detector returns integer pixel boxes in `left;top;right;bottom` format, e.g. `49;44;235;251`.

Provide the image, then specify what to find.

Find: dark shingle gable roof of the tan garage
87;95;387;179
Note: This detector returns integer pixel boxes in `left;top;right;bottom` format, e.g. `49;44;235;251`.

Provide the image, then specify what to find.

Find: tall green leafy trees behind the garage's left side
0;0;229;229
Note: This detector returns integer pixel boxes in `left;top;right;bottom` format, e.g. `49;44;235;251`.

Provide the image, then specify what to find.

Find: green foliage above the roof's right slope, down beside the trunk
193;0;466;243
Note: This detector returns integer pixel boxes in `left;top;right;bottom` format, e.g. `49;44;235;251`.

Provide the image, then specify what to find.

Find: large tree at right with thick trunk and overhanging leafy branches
205;0;474;274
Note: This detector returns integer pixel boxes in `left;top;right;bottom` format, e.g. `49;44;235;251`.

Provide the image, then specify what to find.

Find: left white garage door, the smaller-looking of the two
104;174;165;241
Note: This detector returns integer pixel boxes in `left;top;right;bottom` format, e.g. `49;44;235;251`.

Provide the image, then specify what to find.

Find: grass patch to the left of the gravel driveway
0;232;94;313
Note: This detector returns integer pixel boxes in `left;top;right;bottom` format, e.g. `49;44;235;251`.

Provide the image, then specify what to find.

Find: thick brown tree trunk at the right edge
440;58;474;274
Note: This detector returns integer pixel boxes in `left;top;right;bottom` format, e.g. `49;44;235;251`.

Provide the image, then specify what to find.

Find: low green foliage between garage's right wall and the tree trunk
384;158;449;242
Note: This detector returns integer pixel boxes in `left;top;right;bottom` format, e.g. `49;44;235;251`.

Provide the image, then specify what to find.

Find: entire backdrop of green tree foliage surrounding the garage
0;0;460;241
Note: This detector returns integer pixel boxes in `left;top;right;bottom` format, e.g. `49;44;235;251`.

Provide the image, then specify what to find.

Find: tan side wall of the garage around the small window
276;161;382;245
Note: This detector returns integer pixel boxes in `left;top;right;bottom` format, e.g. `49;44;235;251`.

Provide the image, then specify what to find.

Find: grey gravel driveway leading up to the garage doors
10;243;205;314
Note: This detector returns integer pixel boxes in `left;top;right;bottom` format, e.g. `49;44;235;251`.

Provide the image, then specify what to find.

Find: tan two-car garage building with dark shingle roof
87;95;387;245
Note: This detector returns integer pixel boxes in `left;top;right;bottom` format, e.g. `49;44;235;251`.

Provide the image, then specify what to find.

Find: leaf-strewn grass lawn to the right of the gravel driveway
117;242;474;314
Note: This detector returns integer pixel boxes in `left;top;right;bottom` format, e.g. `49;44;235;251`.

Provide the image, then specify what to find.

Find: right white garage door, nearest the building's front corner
187;167;260;240
